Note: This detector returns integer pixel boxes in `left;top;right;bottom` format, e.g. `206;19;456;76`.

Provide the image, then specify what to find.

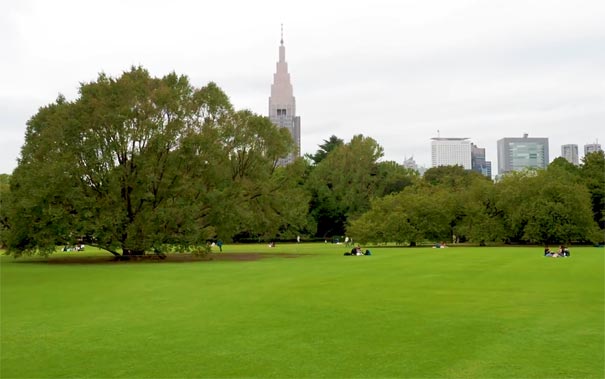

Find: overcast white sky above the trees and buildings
0;0;605;173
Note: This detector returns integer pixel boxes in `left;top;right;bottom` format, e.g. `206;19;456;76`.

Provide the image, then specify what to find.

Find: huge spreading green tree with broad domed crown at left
7;67;302;256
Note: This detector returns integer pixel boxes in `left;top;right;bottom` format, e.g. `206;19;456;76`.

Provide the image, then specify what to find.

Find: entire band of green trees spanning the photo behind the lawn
0;67;605;256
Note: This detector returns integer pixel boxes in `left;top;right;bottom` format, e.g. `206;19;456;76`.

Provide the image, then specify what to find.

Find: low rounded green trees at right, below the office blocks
347;162;605;245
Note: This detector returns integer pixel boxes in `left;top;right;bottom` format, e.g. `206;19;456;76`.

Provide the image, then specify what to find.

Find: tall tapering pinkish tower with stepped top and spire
269;28;300;166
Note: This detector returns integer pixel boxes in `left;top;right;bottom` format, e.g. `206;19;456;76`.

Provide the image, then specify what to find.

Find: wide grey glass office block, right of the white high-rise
498;134;549;175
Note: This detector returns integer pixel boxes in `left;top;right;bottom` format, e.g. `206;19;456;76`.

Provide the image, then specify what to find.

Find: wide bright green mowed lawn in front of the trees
0;243;605;378
